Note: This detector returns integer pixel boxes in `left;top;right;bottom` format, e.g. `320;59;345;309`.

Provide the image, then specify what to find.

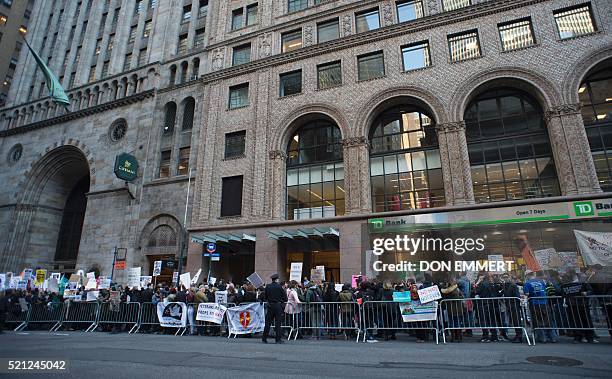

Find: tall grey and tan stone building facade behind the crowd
0;0;612;281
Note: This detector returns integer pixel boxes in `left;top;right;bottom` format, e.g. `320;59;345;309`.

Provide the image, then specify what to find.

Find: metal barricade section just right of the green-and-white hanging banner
439;297;531;345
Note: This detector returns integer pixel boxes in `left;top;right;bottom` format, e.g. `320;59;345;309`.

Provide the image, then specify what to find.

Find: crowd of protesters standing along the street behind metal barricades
0;272;612;343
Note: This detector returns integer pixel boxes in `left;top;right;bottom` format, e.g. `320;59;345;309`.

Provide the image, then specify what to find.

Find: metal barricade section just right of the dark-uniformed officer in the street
289;302;362;342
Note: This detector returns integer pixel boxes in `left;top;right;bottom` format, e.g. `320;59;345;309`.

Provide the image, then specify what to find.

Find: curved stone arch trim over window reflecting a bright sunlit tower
355;86;448;139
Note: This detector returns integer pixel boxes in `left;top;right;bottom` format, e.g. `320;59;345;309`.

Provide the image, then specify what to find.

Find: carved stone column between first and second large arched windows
342;137;372;214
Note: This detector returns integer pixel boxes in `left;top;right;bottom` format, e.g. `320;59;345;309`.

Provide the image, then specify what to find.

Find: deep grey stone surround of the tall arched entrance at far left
0;139;95;270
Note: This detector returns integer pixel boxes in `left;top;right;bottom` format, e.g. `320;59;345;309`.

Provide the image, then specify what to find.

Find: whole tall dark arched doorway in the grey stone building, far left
3;145;91;273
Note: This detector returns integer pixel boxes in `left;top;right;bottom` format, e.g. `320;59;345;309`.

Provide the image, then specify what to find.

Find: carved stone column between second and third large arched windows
436;121;474;205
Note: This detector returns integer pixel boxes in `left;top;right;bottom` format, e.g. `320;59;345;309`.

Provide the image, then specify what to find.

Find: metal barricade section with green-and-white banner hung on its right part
361;301;439;344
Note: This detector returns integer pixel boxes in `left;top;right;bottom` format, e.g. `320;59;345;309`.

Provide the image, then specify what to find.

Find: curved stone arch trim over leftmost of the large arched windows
270;104;351;152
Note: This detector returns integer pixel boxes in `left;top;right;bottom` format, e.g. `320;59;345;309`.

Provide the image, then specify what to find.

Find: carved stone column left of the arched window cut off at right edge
544;104;601;195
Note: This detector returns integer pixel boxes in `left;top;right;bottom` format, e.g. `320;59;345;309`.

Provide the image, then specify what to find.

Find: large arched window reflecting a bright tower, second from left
370;105;446;212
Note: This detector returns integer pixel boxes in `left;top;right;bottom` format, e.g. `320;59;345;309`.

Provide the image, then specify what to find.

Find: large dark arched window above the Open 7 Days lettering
464;88;561;203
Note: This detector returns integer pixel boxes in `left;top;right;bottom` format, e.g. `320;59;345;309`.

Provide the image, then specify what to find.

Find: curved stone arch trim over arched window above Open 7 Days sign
449;67;562;121
